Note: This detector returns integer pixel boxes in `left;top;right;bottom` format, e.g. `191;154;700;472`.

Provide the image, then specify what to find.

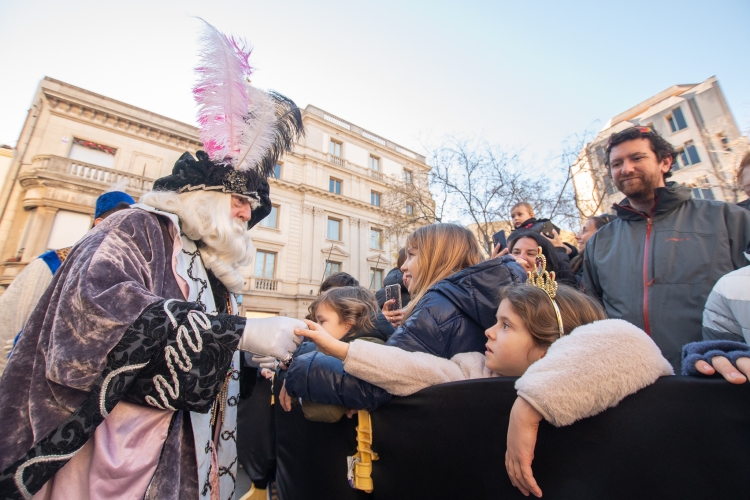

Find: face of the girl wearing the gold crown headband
484;299;546;377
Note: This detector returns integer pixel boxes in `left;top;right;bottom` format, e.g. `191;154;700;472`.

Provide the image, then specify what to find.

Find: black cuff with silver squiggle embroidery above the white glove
125;300;245;413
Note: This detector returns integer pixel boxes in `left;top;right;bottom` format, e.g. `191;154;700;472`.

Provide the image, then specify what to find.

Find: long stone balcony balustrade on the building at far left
31;155;154;191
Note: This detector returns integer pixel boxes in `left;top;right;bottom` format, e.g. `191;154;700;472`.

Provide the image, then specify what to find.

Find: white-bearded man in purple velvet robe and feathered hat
0;22;303;500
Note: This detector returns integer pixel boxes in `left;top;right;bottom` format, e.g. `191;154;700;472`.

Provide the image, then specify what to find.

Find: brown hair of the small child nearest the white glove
307;286;378;340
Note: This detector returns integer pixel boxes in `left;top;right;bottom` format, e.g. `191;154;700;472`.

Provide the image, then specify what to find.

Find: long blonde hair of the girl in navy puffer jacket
404;224;483;319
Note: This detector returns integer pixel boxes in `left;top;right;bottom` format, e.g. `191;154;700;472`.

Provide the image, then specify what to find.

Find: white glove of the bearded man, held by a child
238;316;307;362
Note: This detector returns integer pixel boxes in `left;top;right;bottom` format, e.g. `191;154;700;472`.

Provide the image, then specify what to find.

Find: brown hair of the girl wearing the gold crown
500;283;607;349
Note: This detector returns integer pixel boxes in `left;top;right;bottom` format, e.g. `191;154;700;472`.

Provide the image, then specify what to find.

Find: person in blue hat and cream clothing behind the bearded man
0;191;135;375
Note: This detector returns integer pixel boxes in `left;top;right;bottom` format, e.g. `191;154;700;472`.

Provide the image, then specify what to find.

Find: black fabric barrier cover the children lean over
274;377;750;500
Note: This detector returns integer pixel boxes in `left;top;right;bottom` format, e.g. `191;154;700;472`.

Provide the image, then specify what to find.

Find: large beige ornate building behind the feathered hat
0;78;429;317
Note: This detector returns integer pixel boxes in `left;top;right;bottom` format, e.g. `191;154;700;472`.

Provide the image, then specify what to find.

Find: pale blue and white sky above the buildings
0;0;750;163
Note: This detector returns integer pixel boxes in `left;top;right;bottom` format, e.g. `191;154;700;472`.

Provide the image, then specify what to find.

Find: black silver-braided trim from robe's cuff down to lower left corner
0;300;245;500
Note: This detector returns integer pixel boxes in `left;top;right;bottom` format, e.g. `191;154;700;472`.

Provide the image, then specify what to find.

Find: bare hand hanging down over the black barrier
505;397;542;498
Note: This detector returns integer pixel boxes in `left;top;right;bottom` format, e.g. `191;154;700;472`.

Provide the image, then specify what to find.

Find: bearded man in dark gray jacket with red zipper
583;127;750;371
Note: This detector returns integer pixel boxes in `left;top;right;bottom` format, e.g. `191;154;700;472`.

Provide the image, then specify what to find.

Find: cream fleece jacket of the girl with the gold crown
344;319;674;427
